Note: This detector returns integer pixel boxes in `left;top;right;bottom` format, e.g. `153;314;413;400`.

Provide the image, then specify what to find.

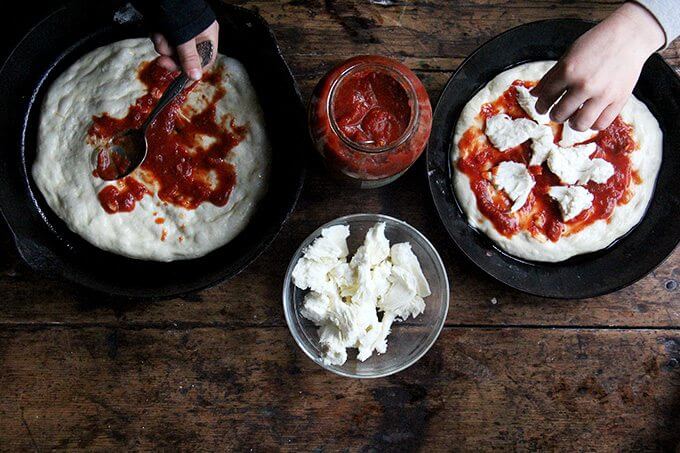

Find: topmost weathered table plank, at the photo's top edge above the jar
230;0;680;70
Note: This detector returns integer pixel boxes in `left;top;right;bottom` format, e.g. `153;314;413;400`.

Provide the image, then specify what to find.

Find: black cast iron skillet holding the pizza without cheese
0;1;309;298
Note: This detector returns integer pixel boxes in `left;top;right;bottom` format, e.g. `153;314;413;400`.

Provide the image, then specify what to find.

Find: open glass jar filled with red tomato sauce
309;56;432;188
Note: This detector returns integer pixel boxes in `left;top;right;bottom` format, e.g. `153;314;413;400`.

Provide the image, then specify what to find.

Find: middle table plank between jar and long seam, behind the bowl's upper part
0;159;680;327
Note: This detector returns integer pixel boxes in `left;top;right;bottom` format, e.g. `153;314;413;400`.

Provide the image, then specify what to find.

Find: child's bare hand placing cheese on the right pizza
532;3;665;131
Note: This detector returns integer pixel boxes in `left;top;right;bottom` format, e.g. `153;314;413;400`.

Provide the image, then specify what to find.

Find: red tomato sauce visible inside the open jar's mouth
333;70;411;148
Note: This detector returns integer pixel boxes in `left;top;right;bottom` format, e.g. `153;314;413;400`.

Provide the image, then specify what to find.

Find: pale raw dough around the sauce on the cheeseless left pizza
33;39;270;261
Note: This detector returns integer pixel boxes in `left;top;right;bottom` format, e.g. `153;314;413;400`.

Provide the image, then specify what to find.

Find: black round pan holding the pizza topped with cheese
427;20;680;298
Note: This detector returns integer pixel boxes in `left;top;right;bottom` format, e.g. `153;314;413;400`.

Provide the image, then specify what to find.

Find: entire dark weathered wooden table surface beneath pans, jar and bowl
0;0;680;451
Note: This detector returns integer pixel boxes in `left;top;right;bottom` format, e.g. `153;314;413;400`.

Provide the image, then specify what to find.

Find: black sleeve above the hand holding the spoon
132;0;215;46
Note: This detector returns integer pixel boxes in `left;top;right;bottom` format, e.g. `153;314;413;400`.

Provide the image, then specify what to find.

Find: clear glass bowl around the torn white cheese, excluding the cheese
283;214;449;378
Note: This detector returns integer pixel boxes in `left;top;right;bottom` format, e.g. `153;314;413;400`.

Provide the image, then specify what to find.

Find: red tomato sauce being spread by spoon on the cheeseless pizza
88;63;247;214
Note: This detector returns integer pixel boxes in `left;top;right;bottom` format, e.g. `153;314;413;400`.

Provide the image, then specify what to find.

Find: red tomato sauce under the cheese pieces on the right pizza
457;80;642;242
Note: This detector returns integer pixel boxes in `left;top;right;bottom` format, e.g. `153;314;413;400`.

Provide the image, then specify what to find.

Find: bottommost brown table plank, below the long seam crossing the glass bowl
0;328;680;451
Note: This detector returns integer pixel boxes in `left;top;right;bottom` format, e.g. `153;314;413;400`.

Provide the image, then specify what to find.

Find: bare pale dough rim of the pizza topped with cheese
451;61;663;262
